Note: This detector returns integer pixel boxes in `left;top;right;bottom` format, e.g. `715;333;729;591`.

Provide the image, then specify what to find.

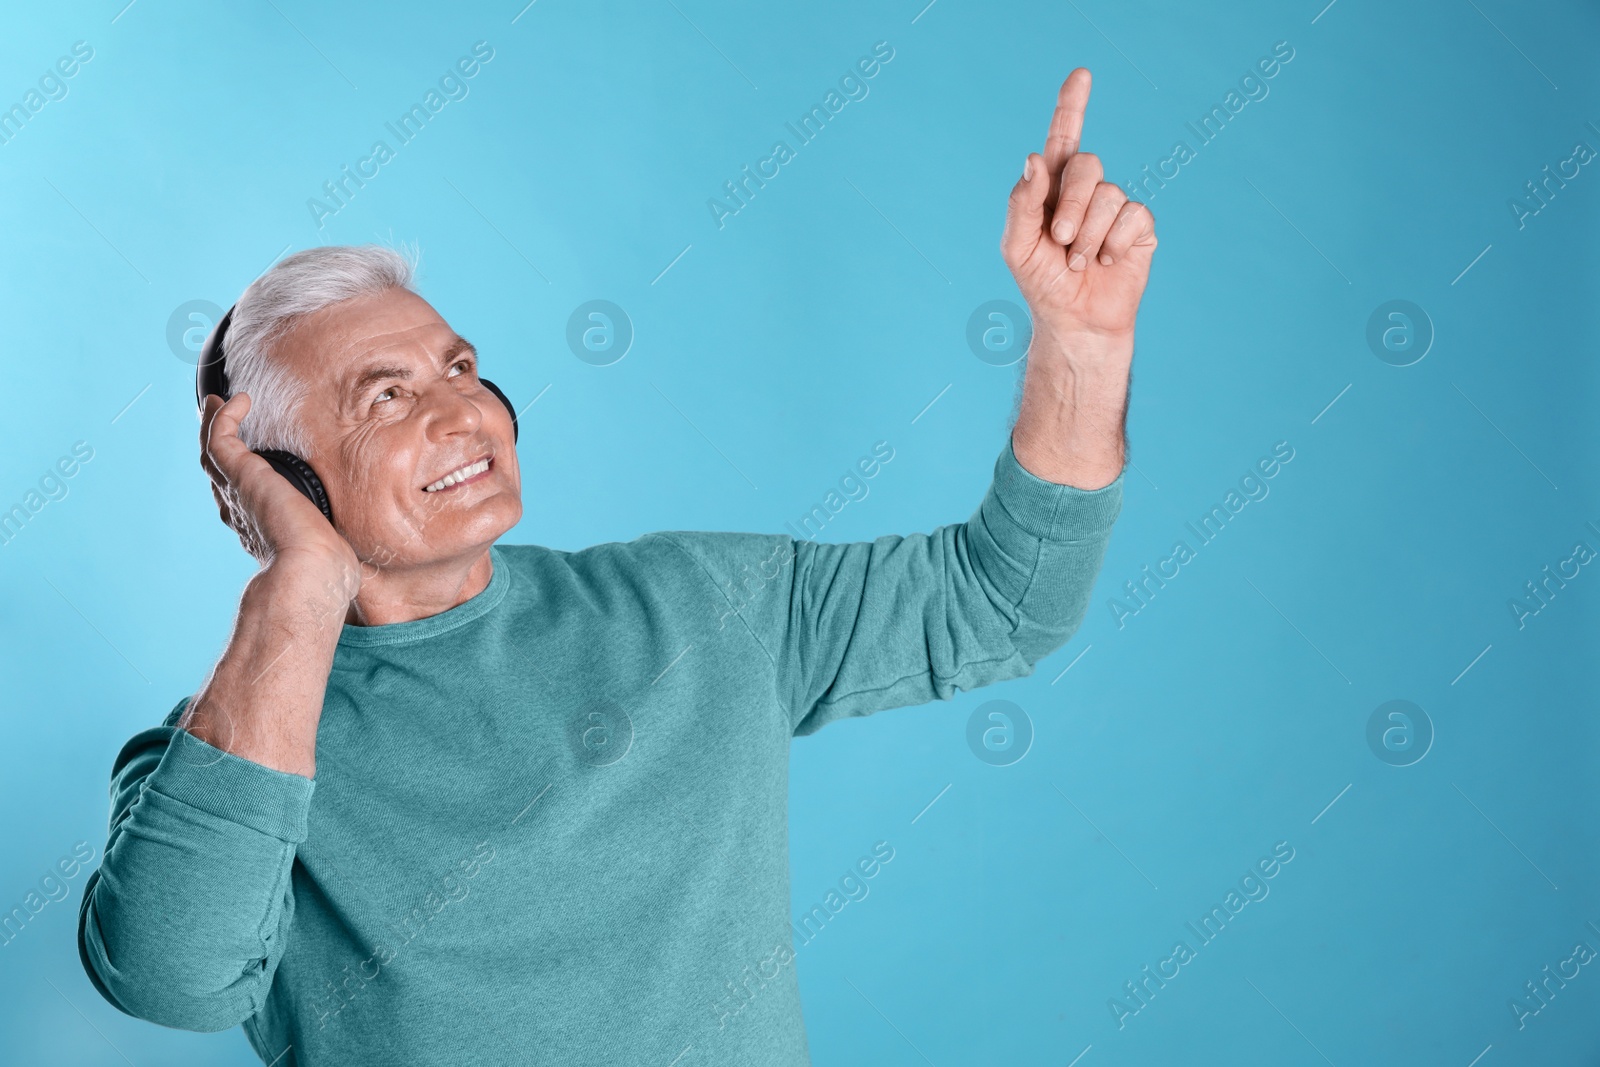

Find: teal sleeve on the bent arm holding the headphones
78;697;315;1032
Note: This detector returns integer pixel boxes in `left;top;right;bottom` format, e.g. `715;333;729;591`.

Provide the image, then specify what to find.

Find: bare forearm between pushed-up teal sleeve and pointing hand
1011;334;1133;490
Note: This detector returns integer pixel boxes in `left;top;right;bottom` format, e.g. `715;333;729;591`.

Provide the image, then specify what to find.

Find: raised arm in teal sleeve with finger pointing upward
672;67;1155;734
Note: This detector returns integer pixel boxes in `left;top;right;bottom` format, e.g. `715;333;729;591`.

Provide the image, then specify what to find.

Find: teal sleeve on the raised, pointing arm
662;435;1123;736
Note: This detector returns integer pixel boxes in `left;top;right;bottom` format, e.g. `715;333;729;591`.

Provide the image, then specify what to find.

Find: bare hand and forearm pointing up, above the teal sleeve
1000;67;1155;490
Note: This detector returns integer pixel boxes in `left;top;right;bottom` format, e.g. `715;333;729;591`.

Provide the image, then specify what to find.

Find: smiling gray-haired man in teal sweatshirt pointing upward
78;69;1155;1067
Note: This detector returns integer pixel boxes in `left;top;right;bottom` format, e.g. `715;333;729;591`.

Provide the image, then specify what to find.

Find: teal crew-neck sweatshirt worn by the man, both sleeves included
78;442;1123;1067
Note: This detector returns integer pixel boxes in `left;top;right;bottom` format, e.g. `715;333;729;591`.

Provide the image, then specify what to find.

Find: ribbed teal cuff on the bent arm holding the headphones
144;726;317;845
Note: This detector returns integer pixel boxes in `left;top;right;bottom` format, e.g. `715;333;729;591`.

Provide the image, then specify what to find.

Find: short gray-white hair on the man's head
224;245;418;458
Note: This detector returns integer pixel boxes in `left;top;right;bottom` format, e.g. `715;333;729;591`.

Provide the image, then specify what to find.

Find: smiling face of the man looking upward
274;290;522;568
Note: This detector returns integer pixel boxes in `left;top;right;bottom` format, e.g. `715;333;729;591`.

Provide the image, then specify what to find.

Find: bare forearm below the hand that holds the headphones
178;563;349;777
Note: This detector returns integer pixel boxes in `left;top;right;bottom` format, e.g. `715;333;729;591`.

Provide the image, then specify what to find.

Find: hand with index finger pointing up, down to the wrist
1000;67;1155;362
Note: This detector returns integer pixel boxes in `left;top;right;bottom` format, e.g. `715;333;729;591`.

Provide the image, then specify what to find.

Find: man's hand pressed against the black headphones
200;394;362;598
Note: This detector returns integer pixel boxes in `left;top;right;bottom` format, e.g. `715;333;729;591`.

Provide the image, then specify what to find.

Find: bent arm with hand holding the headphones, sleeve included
78;397;360;1030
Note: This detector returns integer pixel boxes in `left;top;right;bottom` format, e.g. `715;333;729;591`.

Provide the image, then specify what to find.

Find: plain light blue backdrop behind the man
0;0;1600;1067
